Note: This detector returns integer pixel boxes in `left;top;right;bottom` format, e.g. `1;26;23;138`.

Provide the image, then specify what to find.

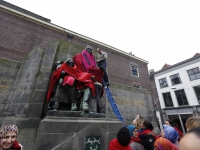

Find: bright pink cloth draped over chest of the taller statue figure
82;50;97;72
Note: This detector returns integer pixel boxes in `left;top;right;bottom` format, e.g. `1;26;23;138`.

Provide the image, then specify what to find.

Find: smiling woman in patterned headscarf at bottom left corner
0;125;23;150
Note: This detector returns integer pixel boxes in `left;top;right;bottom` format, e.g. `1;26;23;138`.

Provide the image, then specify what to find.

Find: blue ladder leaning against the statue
103;80;126;127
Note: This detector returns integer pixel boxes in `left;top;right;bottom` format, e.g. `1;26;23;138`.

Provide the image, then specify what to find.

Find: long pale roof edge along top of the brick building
0;0;149;64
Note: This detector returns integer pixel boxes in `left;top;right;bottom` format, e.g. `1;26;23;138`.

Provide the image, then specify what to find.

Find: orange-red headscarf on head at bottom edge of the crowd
154;137;178;150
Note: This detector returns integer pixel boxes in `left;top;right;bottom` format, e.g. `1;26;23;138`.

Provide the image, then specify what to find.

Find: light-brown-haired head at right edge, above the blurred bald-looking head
185;116;200;132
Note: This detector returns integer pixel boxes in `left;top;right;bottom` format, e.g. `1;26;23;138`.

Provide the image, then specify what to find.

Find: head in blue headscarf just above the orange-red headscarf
161;125;179;143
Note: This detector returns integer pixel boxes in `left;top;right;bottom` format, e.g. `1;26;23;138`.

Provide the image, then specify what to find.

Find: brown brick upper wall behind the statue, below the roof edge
0;10;150;89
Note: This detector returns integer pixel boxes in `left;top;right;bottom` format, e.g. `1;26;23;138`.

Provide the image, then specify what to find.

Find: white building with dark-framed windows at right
154;53;200;133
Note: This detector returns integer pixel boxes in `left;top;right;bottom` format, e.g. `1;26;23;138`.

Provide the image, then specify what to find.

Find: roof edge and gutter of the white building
154;54;200;75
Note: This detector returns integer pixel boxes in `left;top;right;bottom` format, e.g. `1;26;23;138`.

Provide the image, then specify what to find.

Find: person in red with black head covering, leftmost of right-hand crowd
108;127;132;150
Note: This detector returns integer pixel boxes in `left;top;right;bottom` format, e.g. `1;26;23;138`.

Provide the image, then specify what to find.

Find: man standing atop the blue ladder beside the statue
96;48;109;86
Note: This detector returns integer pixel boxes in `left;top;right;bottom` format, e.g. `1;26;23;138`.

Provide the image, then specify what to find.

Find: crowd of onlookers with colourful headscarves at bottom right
108;115;200;150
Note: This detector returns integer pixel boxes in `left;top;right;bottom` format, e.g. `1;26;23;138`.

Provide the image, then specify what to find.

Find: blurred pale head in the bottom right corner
179;127;200;150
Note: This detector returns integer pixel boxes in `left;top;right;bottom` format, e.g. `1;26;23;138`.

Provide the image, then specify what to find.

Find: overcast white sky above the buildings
6;0;200;71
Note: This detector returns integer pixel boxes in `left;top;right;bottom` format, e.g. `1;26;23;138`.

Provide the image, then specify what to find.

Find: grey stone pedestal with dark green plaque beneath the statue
35;115;123;150
